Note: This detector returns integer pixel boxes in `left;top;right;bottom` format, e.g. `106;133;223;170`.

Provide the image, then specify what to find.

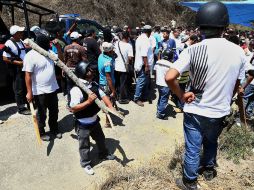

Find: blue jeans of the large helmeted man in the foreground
183;113;224;180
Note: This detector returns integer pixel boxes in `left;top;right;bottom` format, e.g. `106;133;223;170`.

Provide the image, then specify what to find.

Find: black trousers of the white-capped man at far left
12;68;27;111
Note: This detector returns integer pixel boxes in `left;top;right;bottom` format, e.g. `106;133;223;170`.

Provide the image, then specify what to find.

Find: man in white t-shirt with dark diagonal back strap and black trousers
115;32;133;104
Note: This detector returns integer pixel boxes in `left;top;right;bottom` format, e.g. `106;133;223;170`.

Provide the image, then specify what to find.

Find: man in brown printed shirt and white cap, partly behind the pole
63;32;87;104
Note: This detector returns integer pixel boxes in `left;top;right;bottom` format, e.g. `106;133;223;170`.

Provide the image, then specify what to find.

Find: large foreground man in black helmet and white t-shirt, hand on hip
166;1;246;190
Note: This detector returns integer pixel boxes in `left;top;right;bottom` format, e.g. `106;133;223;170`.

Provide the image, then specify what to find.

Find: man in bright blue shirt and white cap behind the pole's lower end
98;42;116;127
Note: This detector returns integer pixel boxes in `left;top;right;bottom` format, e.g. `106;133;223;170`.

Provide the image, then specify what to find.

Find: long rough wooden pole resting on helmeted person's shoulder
24;39;124;119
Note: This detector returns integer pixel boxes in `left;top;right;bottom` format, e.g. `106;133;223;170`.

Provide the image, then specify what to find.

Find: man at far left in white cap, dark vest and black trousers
3;25;31;115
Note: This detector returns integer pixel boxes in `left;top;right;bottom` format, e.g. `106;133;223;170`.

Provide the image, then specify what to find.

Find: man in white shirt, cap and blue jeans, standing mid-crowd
134;25;153;107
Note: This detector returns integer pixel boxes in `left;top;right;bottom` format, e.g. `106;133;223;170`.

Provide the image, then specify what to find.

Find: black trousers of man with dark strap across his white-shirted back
115;71;129;100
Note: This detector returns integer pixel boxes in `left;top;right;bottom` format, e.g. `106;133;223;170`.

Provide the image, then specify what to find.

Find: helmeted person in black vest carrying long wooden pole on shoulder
69;62;115;175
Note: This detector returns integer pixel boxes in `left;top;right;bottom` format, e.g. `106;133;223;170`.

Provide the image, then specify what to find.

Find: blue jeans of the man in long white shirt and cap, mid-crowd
134;68;149;101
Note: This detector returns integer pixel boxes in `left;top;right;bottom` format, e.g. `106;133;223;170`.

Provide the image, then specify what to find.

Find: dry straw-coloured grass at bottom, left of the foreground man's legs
101;146;183;190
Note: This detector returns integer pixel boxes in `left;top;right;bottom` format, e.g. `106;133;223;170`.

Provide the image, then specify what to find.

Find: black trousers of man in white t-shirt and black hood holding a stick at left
34;92;58;135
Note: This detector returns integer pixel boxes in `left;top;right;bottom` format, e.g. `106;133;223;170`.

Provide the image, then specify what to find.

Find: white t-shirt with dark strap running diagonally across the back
115;41;133;72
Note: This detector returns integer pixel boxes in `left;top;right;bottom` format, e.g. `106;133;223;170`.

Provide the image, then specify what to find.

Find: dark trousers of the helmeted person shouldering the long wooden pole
76;121;108;167
